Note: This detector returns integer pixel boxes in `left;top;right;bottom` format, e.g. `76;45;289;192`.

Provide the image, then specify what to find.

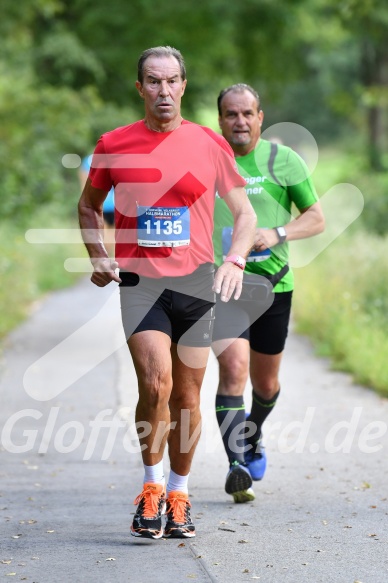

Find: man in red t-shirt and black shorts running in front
79;47;256;539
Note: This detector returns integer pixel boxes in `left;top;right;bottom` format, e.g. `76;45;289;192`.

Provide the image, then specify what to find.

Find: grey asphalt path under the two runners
0;279;388;583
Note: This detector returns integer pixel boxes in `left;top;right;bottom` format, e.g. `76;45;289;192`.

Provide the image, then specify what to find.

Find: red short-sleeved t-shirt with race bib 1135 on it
89;120;245;277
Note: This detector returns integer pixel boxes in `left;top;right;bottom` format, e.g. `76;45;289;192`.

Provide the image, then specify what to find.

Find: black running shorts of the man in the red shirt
120;263;215;347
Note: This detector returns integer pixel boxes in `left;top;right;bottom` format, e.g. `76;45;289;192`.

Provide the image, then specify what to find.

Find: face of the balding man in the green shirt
218;91;264;156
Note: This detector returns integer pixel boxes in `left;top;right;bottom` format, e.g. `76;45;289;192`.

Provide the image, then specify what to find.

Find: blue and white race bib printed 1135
137;205;190;247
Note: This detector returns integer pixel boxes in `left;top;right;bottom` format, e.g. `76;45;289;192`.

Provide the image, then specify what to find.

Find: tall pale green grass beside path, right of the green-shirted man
294;231;388;396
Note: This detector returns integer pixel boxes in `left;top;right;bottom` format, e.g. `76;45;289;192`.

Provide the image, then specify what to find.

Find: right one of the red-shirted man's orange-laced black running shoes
164;492;195;538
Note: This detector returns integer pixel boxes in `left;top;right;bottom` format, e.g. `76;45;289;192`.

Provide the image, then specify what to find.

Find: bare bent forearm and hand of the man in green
255;202;325;251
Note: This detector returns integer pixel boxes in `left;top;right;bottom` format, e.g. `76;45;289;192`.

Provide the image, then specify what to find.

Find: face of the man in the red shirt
136;56;186;125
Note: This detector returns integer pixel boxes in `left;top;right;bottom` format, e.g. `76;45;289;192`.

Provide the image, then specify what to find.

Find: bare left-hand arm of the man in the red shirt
78;178;121;287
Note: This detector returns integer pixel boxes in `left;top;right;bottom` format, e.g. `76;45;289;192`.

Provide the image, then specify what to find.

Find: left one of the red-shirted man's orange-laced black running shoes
131;482;166;538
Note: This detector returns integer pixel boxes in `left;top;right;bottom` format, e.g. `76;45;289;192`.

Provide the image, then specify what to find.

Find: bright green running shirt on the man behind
213;139;318;292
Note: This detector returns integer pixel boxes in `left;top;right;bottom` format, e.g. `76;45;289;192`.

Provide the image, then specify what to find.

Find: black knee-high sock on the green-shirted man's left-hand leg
216;395;245;464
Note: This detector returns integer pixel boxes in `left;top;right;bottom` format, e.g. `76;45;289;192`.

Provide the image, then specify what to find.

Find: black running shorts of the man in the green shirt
213;291;292;354
